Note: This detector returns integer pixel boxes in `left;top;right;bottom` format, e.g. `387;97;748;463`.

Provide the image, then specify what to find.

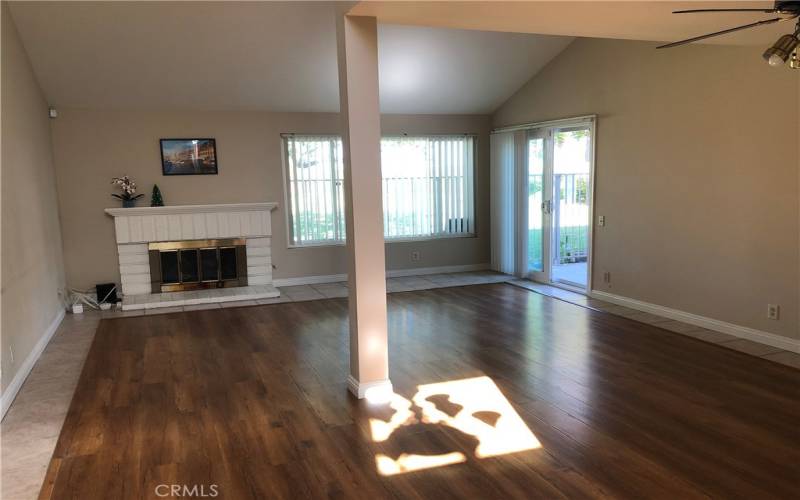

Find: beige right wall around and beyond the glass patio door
493;39;800;338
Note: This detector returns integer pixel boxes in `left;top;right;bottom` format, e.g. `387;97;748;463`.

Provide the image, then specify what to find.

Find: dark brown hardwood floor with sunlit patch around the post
41;284;800;499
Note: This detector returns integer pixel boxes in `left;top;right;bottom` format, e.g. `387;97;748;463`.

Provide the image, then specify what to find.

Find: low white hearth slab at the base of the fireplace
122;285;281;311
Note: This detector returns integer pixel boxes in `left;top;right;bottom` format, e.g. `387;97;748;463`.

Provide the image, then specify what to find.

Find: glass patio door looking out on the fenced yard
524;123;593;290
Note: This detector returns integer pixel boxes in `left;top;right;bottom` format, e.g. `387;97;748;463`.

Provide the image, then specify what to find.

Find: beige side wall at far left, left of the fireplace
0;2;64;391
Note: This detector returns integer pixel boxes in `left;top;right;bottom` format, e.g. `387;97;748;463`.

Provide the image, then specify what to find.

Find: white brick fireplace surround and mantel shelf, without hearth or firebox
105;202;278;295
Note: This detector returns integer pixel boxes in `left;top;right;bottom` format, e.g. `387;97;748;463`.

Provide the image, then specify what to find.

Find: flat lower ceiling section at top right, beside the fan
350;0;794;45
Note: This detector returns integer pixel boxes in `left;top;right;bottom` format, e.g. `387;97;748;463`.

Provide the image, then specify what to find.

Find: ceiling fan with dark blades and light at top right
656;0;800;69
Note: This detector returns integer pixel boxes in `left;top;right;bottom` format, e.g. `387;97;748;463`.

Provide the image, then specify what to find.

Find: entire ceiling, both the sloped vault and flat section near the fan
4;2;782;113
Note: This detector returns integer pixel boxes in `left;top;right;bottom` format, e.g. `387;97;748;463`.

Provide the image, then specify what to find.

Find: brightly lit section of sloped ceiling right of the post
378;24;573;114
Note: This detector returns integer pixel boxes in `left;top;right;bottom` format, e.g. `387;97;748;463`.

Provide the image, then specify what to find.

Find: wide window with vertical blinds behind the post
284;135;475;246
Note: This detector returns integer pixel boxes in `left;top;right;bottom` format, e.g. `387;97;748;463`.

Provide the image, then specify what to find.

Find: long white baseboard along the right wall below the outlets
589;290;800;353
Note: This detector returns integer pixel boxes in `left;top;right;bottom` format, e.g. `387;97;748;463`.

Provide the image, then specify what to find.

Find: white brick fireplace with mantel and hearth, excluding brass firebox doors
105;203;280;309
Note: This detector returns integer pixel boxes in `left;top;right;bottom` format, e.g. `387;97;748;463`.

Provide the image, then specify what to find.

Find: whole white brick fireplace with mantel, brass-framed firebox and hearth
105;202;280;310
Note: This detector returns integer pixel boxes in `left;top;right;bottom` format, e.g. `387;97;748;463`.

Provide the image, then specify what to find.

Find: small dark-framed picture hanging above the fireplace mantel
161;139;217;175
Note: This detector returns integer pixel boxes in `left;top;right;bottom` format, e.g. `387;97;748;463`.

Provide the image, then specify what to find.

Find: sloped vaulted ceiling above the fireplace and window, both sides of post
11;2;572;113
